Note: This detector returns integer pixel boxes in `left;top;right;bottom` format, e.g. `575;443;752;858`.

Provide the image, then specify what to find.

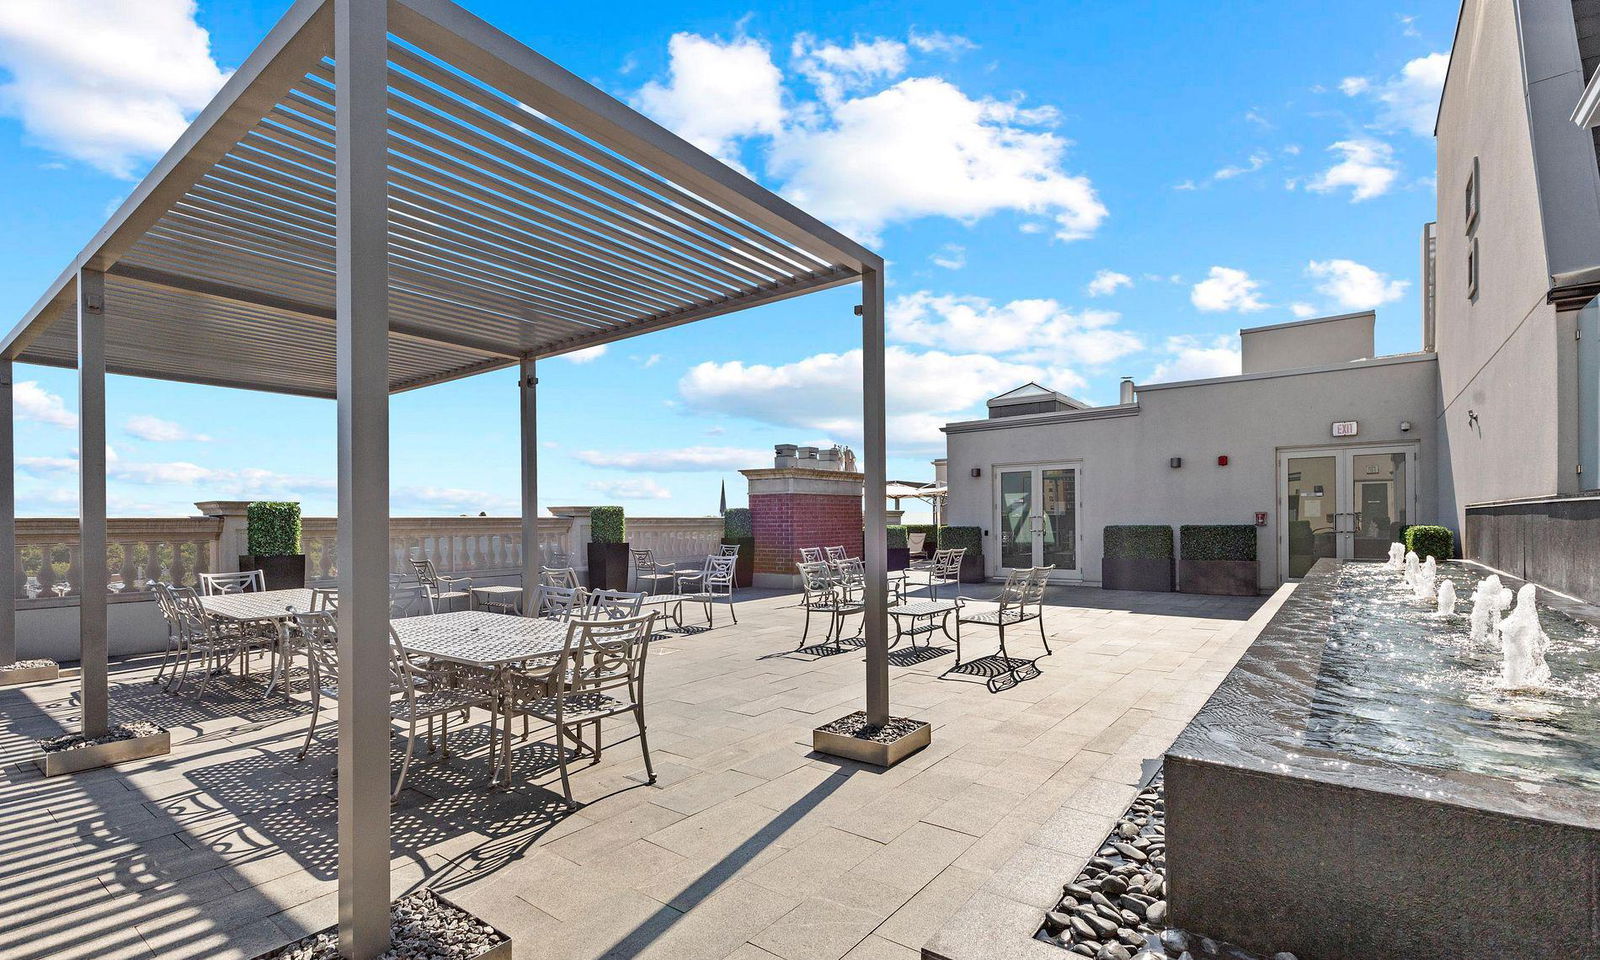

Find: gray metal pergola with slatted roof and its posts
0;0;888;958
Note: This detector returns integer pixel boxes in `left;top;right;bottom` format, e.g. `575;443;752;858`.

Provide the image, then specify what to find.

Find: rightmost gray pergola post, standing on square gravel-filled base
861;267;890;725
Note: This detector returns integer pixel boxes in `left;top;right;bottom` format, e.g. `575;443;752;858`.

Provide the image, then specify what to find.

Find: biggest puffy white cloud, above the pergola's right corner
768;77;1106;242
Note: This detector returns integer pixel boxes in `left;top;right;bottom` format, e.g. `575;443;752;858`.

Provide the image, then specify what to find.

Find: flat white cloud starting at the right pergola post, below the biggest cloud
885;291;1142;365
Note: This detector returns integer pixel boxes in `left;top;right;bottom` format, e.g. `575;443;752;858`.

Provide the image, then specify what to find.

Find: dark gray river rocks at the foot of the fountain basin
1034;774;1296;960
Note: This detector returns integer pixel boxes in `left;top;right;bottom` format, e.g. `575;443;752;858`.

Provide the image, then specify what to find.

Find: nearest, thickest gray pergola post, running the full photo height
333;0;389;960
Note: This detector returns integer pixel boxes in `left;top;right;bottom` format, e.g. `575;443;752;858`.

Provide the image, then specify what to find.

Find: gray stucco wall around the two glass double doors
946;355;1438;587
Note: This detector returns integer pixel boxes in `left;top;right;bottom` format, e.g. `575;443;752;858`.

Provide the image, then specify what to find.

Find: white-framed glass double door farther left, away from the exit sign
995;464;1082;576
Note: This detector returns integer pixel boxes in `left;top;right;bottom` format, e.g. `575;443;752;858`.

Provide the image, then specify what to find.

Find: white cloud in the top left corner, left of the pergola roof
0;0;227;178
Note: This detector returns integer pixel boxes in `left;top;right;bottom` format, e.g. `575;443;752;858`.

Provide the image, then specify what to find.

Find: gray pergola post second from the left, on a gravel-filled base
78;270;110;736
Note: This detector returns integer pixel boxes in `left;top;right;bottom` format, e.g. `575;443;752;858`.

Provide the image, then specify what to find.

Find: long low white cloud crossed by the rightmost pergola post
678;346;1085;454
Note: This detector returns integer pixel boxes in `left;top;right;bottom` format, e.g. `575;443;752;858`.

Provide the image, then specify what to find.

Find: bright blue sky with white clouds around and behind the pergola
0;0;1456;515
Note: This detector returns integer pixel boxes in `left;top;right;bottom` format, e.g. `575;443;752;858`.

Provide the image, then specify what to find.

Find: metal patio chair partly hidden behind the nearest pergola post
294;611;496;800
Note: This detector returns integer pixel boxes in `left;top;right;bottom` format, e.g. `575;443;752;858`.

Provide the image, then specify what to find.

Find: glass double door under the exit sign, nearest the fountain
1278;446;1416;579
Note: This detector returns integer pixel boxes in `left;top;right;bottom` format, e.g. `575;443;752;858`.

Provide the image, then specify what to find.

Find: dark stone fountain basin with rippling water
1165;560;1600;960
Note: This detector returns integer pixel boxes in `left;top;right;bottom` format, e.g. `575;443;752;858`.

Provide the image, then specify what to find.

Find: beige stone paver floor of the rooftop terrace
0;587;1261;960
